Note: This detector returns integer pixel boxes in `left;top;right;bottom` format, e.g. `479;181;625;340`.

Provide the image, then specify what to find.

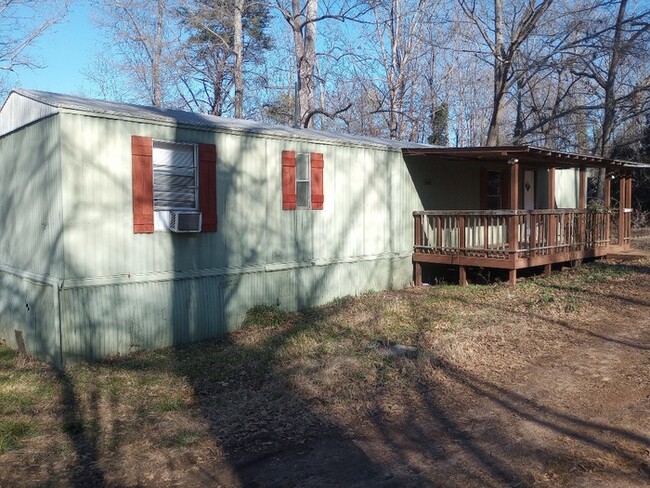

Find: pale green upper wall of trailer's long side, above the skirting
58;115;420;278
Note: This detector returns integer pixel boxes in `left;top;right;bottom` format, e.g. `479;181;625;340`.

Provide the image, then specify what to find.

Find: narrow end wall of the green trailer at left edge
0;117;63;361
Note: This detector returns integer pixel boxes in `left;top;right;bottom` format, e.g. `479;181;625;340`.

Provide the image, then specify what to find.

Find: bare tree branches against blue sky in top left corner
0;0;69;94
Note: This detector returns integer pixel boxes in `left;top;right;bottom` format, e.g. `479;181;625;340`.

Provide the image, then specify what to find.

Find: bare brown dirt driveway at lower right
229;267;650;488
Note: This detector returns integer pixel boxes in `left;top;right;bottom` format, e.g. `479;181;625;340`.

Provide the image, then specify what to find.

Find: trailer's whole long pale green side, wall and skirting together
52;113;422;361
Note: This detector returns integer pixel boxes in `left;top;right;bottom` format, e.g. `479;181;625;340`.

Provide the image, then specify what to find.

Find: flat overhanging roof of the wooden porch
402;146;650;169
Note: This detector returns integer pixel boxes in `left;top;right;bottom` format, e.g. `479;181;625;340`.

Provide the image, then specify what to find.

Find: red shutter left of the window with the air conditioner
131;136;153;234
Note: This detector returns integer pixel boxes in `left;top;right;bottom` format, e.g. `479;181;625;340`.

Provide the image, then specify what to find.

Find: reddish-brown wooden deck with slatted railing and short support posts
413;209;629;285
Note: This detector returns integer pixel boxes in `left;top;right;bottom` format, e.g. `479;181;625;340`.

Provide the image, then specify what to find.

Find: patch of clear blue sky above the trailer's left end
11;2;99;95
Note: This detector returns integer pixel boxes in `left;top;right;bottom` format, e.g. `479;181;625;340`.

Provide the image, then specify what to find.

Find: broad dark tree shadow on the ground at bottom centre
168;316;408;486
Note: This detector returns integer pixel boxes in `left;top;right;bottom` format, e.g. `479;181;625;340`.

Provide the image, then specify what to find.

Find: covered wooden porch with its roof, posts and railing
405;146;643;285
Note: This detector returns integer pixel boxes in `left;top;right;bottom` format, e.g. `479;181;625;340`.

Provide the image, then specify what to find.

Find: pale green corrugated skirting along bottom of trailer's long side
61;257;411;362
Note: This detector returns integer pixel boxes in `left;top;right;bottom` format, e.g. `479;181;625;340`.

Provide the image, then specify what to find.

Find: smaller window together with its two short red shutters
282;151;325;210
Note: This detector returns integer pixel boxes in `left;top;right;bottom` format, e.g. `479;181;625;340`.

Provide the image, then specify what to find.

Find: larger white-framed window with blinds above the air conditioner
153;141;198;210
